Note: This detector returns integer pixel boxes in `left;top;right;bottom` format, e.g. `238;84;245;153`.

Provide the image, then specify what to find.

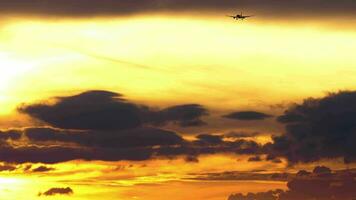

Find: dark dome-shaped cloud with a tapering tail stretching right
18;90;208;130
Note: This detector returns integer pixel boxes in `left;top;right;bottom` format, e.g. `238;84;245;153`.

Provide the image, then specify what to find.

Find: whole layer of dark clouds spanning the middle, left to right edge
0;90;356;164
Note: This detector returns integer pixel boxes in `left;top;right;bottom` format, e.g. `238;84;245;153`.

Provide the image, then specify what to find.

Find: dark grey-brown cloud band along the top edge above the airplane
0;0;356;18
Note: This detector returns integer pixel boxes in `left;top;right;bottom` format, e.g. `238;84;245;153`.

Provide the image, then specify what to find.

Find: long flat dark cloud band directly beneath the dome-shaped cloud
0;127;263;163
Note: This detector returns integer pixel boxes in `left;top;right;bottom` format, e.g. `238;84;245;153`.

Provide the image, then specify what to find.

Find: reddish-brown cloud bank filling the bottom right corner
228;166;356;200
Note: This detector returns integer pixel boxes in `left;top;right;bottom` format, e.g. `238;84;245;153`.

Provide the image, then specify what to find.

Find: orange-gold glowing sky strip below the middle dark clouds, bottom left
0;155;286;200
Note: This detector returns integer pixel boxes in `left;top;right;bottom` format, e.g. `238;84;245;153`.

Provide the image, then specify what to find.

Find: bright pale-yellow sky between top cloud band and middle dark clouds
0;16;356;117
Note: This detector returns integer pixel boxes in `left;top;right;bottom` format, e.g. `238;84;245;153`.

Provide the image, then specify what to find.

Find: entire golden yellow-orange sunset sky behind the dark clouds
0;0;356;200
